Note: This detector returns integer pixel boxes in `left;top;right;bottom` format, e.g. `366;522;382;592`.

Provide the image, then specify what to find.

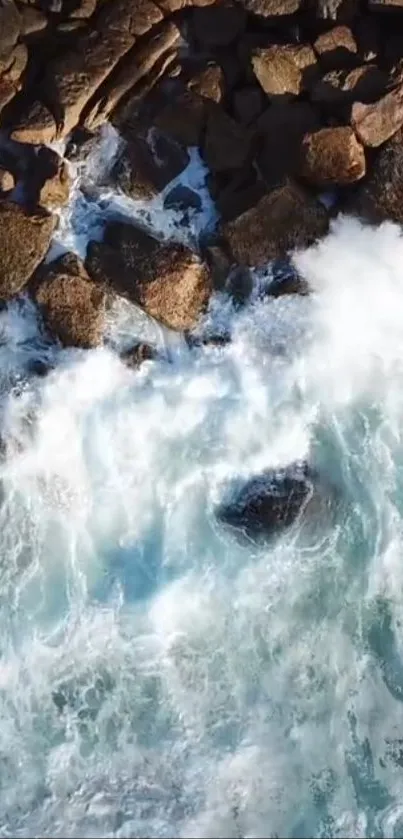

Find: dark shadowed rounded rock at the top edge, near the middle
191;0;246;48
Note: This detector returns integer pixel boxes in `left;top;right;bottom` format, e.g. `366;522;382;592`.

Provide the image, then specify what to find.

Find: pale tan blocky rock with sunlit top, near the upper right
252;45;316;96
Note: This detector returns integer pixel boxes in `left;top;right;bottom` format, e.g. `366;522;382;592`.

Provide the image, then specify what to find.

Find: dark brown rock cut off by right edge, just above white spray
346;129;403;224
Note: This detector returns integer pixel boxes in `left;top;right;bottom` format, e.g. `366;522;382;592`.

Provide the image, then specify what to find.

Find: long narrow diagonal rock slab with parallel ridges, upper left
83;21;180;131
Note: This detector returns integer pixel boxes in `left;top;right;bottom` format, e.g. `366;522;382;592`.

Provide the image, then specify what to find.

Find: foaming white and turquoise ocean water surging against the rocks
0;136;403;839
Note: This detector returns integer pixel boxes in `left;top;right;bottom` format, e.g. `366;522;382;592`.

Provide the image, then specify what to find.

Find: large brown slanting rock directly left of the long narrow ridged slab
43;0;163;136
